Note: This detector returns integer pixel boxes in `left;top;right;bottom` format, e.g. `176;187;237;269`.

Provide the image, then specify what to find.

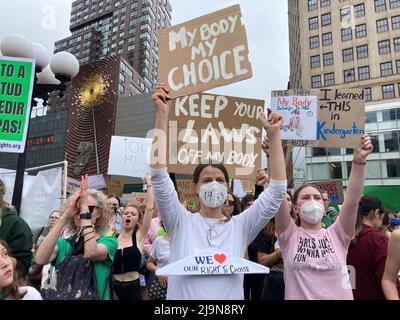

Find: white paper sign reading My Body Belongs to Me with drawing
271;96;318;140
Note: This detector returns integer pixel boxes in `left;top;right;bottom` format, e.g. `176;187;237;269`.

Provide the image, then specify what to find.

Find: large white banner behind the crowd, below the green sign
0;168;62;229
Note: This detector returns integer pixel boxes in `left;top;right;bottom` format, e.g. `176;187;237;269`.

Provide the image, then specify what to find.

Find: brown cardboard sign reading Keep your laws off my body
168;93;264;181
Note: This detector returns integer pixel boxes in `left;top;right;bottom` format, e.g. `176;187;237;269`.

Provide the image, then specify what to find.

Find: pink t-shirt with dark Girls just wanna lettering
278;219;353;300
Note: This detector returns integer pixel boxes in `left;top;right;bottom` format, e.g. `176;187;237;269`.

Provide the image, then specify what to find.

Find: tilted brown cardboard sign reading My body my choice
157;5;252;98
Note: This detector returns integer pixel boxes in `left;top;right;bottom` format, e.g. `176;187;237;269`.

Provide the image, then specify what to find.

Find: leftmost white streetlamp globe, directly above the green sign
0;34;34;58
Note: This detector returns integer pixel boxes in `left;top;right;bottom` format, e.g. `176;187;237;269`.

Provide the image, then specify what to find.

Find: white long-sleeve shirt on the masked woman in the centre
150;169;287;300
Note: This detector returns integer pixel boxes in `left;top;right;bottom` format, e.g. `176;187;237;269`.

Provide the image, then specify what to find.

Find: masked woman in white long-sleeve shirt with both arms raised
150;84;287;300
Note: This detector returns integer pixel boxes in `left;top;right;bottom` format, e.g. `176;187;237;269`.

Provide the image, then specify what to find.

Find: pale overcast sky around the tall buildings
0;0;289;102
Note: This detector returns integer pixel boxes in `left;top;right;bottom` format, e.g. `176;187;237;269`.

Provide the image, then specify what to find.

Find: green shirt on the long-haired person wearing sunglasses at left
56;235;118;300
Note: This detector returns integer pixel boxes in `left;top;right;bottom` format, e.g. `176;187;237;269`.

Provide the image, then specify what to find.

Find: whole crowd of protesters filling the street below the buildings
0;84;400;300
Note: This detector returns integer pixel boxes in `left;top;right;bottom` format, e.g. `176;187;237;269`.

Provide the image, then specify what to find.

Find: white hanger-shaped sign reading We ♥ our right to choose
156;248;269;276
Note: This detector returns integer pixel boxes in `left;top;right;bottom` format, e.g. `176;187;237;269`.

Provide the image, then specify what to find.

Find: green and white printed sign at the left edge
0;57;35;153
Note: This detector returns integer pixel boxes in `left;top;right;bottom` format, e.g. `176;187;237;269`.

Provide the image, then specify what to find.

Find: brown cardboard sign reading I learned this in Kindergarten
316;89;365;148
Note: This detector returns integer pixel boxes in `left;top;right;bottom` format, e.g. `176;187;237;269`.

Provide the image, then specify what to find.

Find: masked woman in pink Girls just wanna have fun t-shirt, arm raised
275;134;373;300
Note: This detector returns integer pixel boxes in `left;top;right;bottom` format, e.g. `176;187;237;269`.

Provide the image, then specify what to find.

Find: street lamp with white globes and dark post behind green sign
0;35;79;213
